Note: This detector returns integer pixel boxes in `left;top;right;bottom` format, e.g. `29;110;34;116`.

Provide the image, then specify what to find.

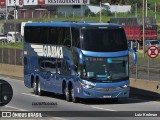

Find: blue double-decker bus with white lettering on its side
24;22;136;102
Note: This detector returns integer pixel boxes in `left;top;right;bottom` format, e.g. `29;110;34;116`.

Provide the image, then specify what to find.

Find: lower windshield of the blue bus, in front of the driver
82;56;128;82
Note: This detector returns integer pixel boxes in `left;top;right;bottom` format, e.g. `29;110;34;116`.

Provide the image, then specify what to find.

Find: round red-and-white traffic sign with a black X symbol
147;46;159;58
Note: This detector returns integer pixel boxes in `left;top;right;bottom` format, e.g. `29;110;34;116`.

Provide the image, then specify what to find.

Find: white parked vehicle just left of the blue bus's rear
7;32;23;43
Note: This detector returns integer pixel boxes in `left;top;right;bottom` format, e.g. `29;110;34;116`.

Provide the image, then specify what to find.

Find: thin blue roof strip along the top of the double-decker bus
25;21;122;28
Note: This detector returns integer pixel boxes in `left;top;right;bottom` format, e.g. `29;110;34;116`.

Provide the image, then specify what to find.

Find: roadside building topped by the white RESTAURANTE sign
6;0;90;19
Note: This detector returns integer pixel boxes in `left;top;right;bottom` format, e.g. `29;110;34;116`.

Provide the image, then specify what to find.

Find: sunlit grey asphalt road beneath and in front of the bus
0;77;160;120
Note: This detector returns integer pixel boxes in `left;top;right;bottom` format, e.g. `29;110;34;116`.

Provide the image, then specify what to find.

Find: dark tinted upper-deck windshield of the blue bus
81;28;128;52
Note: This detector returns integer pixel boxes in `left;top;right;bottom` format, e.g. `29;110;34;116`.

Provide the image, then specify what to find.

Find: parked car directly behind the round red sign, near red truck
145;40;160;51
